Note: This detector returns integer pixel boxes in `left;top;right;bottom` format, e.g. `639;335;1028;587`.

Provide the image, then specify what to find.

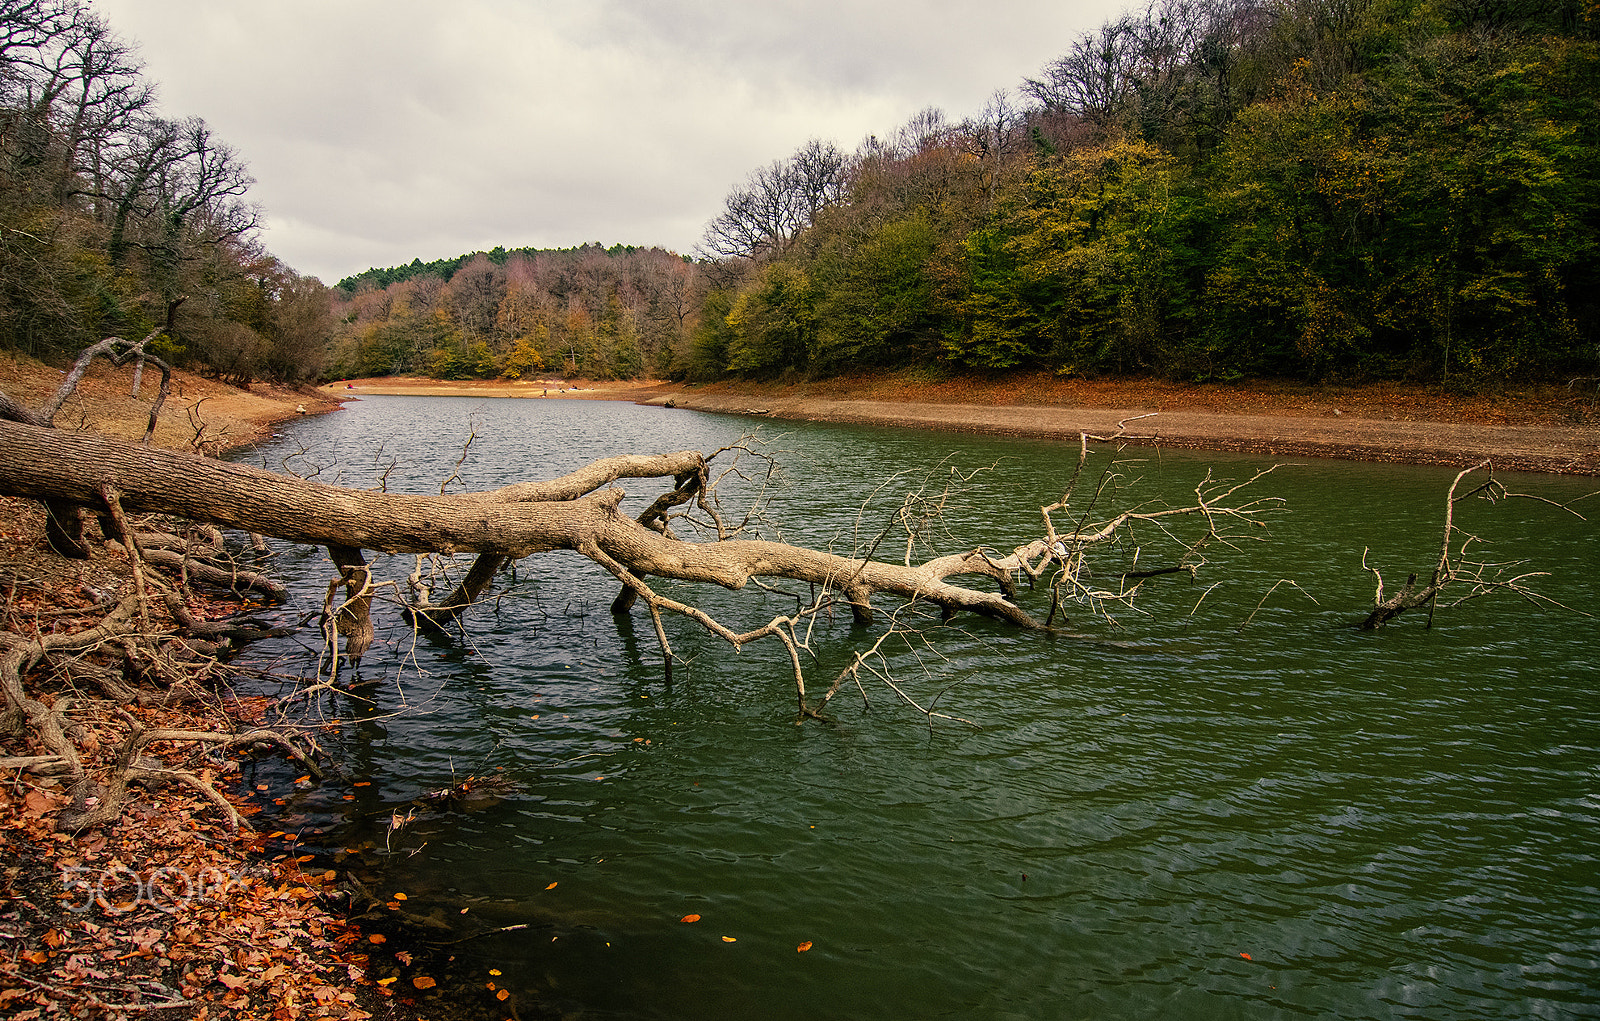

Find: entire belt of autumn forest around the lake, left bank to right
0;0;1600;384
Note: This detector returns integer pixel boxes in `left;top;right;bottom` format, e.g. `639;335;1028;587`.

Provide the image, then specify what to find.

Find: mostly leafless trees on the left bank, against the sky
0;0;333;381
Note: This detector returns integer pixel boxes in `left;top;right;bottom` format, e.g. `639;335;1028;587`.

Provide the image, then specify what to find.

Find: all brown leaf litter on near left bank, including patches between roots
0;499;406;1021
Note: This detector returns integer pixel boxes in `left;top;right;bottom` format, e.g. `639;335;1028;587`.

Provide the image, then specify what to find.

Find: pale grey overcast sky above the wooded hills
84;0;1130;283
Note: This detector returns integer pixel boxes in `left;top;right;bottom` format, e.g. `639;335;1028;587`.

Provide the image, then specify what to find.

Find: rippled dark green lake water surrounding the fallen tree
236;397;1600;1019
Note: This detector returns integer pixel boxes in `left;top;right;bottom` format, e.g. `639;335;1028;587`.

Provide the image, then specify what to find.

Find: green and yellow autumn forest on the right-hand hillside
691;0;1600;379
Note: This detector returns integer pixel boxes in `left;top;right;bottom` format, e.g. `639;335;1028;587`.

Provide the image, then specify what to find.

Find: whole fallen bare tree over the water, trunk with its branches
0;364;1272;732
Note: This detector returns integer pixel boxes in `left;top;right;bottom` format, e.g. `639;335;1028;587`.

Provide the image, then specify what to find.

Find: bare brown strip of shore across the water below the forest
322;373;1600;475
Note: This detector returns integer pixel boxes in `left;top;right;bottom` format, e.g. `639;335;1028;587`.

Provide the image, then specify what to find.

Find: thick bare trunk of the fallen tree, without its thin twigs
0;421;1042;627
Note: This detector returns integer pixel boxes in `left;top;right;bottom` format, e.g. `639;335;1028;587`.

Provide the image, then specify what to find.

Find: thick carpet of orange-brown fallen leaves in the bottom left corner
0;771;387;1021
